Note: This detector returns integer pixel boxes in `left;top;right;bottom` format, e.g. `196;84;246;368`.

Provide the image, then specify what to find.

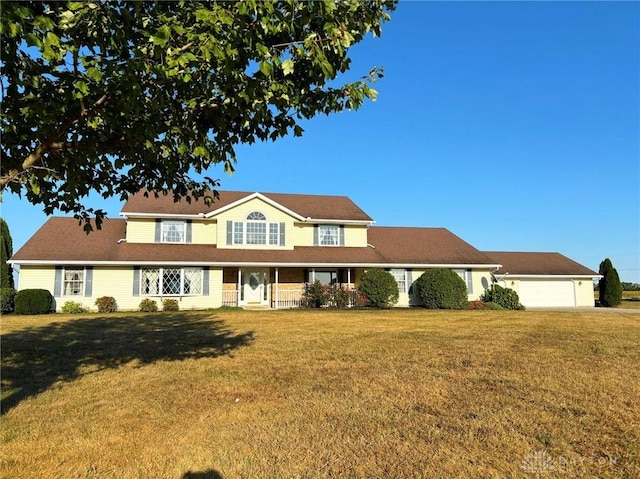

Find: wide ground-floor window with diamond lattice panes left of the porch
140;268;202;296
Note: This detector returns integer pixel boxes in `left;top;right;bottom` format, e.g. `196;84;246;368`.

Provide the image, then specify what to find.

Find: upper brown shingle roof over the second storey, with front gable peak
121;191;373;222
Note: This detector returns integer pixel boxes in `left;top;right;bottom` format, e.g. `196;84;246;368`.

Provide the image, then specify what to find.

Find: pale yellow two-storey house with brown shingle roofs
10;191;597;310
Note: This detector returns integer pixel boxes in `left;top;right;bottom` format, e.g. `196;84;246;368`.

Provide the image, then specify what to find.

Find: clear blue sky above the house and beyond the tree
1;1;640;283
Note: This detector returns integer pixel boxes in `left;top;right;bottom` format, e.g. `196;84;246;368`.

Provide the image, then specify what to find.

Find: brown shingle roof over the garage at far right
485;251;599;277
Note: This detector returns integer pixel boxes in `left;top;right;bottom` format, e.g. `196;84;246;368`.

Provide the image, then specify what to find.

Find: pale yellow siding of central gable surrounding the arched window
216;198;299;250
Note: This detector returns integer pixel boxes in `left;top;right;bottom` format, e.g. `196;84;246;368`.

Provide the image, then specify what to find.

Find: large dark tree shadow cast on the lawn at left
1;312;253;414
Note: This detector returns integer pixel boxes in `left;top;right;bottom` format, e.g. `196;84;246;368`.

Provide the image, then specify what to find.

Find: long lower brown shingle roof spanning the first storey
11;217;497;268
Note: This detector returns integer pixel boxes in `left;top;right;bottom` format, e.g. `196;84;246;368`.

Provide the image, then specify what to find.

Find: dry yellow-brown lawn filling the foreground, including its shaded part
0;310;640;479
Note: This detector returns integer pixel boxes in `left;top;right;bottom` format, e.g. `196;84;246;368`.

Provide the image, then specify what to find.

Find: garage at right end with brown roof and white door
484;251;600;308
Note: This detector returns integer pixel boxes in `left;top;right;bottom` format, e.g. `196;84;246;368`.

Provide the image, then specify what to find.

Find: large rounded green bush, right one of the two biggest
416;268;469;309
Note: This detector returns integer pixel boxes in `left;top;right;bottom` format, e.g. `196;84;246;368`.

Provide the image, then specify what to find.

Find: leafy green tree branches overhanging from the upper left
0;0;395;229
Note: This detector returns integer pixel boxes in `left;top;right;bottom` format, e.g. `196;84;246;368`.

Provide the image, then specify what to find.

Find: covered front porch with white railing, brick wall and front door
222;267;360;309
